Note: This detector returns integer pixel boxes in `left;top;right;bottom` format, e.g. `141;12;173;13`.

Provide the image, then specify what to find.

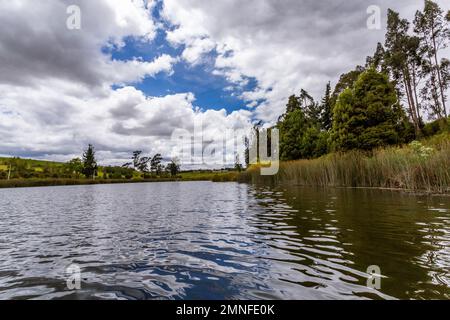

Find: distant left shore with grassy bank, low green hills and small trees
0;145;242;188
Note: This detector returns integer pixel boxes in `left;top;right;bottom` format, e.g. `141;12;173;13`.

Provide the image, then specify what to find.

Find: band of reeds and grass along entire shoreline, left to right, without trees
0;133;450;194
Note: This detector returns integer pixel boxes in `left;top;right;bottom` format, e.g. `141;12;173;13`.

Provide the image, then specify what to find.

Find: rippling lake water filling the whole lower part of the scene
0;182;450;299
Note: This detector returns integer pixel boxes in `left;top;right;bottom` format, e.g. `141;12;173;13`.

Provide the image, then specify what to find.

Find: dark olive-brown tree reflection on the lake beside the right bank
251;188;450;299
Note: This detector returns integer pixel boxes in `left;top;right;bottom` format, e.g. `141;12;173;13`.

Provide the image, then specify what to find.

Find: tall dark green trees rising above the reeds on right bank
245;0;450;166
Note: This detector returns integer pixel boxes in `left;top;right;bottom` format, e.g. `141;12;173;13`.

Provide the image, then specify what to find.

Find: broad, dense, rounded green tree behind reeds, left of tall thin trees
331;69;404;151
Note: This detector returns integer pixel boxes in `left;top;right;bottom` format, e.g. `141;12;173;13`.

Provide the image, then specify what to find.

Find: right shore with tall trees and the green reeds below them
239;0;450;194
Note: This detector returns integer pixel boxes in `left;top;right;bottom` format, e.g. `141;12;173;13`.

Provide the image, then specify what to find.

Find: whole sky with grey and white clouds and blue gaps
0;0;450;168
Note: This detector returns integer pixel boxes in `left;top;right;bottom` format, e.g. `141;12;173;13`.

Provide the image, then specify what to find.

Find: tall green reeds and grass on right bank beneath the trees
238;133;450;193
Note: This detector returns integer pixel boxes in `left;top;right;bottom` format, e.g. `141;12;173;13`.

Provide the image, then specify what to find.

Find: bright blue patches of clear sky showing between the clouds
103;30;257;113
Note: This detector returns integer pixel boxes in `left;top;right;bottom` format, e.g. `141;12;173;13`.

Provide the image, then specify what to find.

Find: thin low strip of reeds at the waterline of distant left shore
0;171;238;188
